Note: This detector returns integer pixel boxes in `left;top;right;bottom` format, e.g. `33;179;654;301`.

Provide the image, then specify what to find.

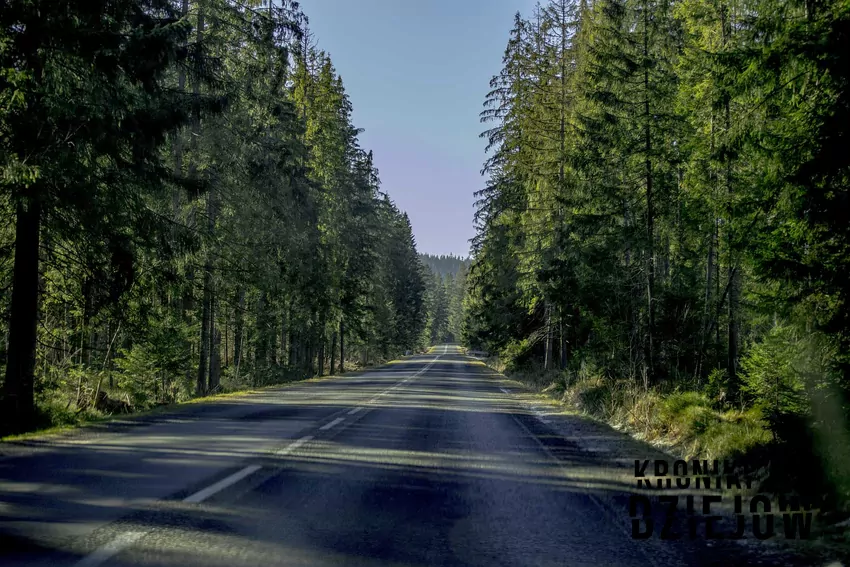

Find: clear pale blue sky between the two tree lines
301;0;535;256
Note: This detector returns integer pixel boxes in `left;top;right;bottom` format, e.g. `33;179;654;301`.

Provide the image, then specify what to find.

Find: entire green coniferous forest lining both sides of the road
0;0;850;524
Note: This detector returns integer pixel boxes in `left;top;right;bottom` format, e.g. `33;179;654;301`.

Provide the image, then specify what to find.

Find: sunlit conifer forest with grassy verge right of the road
463;0;850;509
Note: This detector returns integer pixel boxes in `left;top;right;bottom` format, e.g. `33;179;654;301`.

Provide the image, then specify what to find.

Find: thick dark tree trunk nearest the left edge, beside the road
3;199;41;432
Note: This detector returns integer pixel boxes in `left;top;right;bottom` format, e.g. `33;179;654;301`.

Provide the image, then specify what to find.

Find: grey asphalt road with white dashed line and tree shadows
0;346;820;567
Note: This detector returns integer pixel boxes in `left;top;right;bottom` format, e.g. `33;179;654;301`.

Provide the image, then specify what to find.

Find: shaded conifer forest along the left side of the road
0;0;424;434
